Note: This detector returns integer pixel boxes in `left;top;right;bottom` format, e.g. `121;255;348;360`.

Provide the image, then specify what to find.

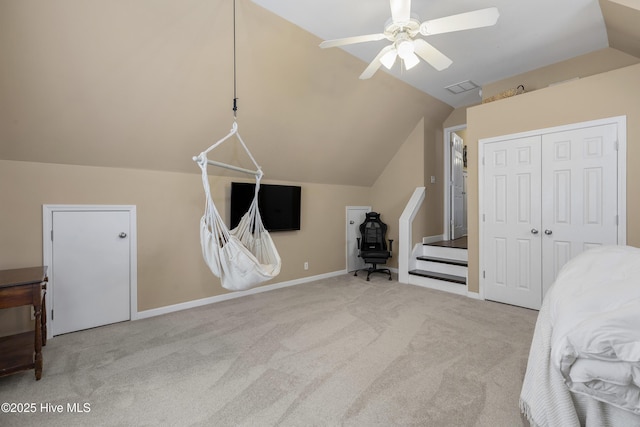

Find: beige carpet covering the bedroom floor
0;275;537;427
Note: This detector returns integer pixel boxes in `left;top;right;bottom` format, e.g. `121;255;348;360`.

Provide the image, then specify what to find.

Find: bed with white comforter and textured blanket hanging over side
520;246;640;427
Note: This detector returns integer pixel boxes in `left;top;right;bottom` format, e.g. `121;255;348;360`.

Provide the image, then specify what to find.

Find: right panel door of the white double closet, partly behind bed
541;124;618;293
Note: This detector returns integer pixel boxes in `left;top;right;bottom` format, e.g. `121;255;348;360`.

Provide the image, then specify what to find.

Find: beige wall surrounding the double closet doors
467;64;640;292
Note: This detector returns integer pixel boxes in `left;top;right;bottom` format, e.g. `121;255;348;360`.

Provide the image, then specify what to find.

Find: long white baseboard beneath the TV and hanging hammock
131;270;347;320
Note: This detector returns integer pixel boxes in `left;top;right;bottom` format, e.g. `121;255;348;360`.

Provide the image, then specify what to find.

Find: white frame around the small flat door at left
42;205;138;338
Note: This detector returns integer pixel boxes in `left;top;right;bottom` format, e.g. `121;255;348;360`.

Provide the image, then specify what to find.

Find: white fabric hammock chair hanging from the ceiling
193;122;282;291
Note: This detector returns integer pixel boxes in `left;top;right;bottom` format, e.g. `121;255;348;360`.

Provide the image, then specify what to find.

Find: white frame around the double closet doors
478;116;627;299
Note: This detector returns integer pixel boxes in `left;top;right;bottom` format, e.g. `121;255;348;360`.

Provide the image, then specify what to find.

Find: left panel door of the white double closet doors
482;136;542;309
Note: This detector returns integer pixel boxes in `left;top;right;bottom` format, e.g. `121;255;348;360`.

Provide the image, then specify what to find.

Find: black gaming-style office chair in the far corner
353;212;393;280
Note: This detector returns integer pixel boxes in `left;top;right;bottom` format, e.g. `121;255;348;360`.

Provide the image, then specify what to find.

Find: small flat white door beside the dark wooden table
50;211;131;335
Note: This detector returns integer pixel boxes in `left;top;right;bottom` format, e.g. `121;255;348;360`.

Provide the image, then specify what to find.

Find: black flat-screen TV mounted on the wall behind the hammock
230;182;302;231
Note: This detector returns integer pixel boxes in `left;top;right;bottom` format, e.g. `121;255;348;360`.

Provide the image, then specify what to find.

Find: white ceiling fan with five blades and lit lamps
320;0;500;79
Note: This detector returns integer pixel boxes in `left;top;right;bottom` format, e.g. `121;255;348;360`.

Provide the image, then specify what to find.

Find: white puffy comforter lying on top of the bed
549;246;640;414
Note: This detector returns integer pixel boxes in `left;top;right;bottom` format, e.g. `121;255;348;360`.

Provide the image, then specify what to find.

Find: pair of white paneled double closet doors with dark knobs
481;124;618;309
